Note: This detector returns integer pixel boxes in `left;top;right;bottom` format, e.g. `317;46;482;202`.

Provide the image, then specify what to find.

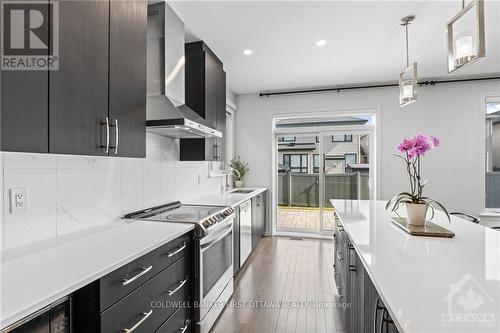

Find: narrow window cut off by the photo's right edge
485;98;500;209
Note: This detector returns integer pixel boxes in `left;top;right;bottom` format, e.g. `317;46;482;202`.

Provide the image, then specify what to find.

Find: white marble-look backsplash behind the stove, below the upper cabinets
0;133;221;249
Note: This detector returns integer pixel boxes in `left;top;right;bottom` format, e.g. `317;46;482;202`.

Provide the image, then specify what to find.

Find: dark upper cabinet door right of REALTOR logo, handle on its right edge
49;0;109;155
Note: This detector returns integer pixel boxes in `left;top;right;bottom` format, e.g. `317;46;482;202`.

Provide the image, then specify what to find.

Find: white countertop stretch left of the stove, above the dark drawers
0;220;194;328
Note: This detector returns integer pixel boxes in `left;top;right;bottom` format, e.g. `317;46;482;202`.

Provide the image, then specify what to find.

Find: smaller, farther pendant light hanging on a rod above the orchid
399;15;417;107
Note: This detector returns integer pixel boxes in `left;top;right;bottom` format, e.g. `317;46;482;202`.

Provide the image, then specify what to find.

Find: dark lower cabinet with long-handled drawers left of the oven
74;233;194;333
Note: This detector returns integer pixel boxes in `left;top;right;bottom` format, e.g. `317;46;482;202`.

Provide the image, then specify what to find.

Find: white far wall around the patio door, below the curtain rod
236;81;500;214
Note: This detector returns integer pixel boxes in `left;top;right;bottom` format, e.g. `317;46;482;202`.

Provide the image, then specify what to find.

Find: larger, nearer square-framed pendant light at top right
446;0;486;73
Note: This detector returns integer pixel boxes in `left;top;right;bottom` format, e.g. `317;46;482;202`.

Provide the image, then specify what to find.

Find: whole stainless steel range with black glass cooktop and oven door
125;201;234;333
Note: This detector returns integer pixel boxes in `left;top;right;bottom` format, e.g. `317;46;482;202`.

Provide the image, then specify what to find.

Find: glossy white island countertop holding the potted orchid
331;200;500;333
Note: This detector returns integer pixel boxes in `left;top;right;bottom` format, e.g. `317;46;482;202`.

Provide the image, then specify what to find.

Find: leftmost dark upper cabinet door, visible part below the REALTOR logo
0;0;49;153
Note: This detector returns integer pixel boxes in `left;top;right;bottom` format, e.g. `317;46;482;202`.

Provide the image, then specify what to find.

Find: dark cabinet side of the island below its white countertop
333;228;398;333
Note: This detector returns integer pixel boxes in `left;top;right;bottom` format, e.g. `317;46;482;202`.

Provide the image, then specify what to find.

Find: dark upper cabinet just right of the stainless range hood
180;41;226;161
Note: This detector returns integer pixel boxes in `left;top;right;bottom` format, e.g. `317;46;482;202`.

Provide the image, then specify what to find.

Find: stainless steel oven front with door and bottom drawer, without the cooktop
195;217;234;333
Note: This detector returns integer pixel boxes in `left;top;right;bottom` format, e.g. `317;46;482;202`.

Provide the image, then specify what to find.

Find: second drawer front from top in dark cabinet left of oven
101;256;193;333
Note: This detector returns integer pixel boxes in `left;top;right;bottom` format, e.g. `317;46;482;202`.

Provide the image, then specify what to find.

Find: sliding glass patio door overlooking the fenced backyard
275;129;374;234
